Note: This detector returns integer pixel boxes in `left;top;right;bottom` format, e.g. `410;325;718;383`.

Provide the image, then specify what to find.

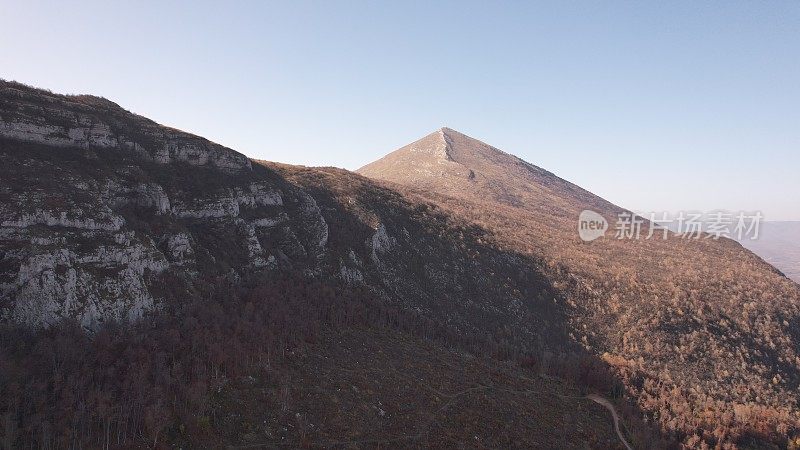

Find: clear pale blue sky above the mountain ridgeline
0;1;800;220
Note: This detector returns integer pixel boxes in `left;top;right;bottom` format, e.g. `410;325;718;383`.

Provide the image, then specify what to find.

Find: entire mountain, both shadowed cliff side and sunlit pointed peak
0;82;800;448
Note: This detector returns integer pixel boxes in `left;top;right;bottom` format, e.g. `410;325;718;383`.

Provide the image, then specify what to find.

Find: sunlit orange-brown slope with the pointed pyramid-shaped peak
358;128;800;445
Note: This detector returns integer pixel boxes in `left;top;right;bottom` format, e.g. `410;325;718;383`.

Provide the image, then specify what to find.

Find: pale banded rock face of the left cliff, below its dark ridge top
0;149;316;328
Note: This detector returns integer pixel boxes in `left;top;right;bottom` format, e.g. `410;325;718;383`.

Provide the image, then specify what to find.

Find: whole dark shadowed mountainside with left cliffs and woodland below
0;82;636;448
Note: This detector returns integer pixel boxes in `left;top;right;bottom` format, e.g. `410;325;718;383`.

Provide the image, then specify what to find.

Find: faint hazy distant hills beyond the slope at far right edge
740;222;800;283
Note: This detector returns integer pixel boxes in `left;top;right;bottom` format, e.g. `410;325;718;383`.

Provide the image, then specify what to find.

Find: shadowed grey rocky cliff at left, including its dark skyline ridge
0;83;327;328
